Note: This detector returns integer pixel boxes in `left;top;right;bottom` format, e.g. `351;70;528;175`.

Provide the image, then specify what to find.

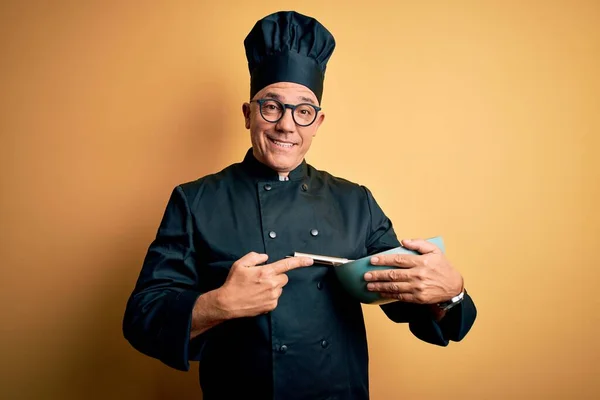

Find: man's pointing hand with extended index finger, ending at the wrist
218;253;313;319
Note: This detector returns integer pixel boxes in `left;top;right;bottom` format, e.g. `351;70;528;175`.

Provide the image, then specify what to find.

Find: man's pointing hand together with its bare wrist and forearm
190;252;313;338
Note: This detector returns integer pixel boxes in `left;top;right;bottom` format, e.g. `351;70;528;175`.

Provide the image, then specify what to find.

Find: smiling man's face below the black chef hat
242;82;325;175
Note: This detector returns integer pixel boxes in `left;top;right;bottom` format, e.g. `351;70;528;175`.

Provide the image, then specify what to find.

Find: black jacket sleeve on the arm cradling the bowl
364;188;477;346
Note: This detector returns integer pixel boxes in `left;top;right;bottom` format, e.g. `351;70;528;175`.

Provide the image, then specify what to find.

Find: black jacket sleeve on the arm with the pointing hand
123;186;208;371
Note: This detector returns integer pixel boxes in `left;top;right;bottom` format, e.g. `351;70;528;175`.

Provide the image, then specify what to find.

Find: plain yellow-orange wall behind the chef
0;0;600;400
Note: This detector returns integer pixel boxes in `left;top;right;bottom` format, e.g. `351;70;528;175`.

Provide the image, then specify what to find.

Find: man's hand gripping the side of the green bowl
364;239;463;304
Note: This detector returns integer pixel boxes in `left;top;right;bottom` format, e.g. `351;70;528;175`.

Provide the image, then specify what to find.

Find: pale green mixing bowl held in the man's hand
334;236;445;304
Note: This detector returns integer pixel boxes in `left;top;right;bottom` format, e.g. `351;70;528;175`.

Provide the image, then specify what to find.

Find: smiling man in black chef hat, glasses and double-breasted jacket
123;12;476;400
